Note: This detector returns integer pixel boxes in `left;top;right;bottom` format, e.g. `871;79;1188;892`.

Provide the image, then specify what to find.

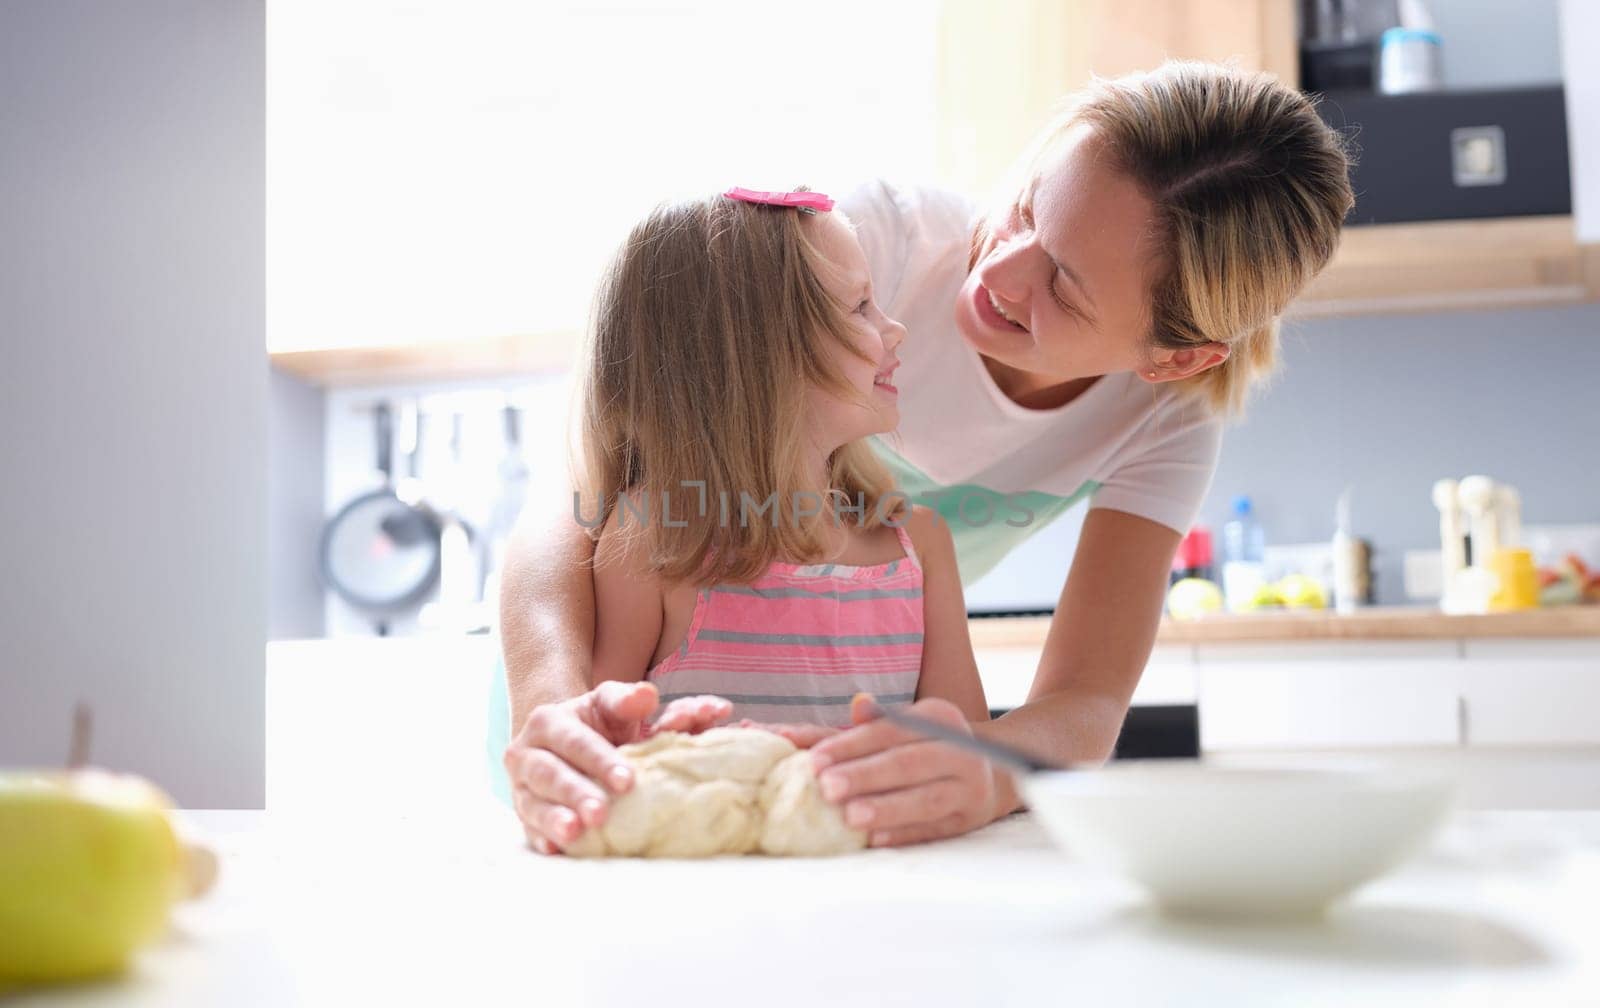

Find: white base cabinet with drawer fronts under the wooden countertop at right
1197;637;1600;808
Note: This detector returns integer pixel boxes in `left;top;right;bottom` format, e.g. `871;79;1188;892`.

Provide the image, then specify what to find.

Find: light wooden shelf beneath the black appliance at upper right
1290;216;1600;318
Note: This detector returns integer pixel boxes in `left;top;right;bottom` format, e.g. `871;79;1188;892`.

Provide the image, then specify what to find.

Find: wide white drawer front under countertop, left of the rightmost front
1197;642;1459;752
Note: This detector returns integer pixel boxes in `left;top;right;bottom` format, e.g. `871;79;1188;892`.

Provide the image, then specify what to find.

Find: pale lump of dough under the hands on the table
566;728;866;858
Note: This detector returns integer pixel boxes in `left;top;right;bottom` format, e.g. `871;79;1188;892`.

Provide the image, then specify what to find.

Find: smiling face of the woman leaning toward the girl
955;126;1154;384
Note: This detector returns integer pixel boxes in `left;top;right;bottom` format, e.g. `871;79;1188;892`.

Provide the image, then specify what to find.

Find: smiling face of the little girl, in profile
805;211;906;453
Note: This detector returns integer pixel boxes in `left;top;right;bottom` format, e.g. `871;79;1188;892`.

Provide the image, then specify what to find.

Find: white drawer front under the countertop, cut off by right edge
1461;638;1600;747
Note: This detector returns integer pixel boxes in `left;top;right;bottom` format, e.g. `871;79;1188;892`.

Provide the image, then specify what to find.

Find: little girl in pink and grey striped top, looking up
574;189;989;726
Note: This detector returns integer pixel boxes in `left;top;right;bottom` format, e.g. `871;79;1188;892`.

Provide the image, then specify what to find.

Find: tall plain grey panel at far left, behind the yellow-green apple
0;0;267;808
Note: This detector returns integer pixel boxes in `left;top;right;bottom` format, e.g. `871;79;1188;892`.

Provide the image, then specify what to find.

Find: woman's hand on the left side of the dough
504;682;731;854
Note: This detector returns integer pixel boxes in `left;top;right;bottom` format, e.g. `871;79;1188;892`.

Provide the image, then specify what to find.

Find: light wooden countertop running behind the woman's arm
968;605;1600;648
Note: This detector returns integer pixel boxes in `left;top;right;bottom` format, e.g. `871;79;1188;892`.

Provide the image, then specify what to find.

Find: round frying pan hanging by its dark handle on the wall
320;403;440;634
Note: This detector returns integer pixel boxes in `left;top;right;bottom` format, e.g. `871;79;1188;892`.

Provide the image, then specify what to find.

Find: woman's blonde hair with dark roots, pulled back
974;61;1355;414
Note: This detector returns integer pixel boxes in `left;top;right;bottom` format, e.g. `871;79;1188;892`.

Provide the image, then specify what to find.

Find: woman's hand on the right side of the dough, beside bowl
811;696;995;846
